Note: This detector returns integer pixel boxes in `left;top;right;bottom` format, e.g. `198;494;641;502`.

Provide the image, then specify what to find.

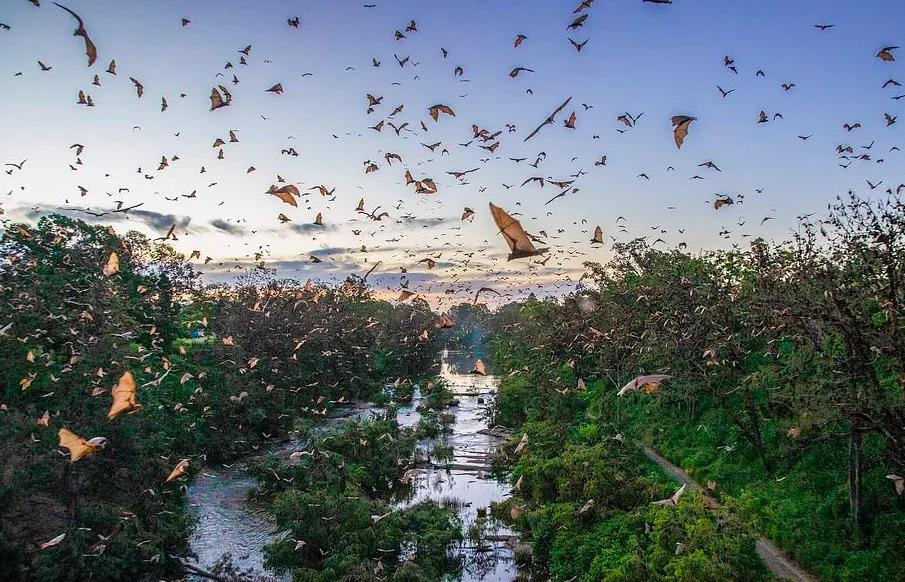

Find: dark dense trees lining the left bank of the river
0;216;439;580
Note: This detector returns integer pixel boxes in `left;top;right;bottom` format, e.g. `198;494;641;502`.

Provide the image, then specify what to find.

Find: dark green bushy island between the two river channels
252;413;462;582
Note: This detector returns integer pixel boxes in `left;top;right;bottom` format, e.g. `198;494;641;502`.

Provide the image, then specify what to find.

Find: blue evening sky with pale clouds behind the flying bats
0;0;905;308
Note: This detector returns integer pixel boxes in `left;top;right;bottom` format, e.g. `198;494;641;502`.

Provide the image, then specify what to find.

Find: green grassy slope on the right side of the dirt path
608;386;905;581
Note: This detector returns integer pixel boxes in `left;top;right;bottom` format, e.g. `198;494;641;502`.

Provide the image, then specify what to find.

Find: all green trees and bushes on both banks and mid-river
7;196;905;581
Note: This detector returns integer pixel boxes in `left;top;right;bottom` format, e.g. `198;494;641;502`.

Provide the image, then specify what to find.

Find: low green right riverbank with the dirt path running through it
484;360;903;581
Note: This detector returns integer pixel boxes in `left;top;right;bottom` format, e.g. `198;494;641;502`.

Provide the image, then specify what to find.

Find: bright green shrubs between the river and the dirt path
484;375;771;582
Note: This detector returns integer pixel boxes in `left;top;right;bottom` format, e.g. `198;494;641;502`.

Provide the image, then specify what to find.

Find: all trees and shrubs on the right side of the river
493;196;905;580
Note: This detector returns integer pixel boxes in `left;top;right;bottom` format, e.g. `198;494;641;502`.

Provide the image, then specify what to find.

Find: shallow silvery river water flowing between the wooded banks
188;351;516;582
